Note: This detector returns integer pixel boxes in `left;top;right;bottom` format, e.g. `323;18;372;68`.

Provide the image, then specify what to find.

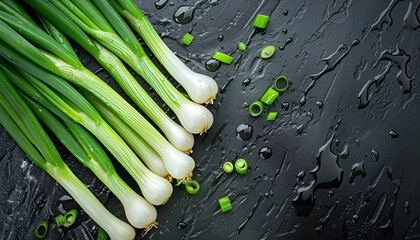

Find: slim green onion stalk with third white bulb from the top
0;2;194;152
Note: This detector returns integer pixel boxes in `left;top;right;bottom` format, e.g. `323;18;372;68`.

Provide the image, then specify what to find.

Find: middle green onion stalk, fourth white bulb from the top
0;6;195;180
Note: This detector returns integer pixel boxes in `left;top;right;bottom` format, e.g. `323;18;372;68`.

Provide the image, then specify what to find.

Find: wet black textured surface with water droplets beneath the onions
0;0;420;239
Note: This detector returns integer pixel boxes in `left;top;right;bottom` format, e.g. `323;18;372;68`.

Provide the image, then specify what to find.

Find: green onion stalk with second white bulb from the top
25;0;213;135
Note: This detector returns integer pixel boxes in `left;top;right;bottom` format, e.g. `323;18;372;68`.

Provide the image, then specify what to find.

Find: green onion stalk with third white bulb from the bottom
0;40;172;205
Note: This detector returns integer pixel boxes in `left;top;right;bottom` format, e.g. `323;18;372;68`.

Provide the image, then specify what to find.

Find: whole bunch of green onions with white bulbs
0;0;217;239
